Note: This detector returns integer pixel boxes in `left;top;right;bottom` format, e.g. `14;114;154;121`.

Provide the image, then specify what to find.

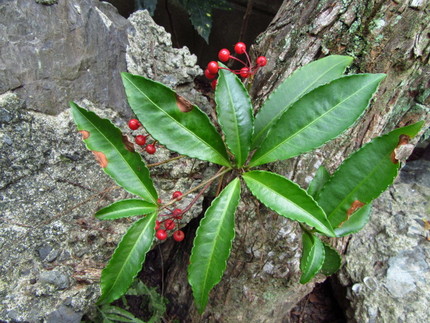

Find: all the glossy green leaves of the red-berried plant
71;56;423;313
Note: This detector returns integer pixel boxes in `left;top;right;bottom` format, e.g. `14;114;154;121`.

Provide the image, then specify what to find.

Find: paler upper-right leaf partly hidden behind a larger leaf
252;55;352;148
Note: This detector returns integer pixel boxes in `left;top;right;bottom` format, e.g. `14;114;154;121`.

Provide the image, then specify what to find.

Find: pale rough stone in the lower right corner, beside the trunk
338;159;430;323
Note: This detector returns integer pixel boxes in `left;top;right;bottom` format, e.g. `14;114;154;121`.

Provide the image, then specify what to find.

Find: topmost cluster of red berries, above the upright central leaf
205;42;267;89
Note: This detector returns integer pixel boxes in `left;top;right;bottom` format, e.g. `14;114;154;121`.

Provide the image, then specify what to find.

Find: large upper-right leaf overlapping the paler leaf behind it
249;74;385;167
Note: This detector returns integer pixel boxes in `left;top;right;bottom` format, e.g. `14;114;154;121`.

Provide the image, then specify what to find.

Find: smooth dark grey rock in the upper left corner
0;0;130;114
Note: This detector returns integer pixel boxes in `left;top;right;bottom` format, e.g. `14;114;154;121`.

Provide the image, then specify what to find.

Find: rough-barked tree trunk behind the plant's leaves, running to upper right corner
154;0;430;322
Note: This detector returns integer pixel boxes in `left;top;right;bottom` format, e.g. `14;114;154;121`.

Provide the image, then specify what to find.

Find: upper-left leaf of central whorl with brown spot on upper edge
121;73;230;166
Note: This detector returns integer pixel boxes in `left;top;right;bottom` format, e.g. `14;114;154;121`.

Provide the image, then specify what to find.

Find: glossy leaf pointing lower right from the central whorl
242;171;335;237
